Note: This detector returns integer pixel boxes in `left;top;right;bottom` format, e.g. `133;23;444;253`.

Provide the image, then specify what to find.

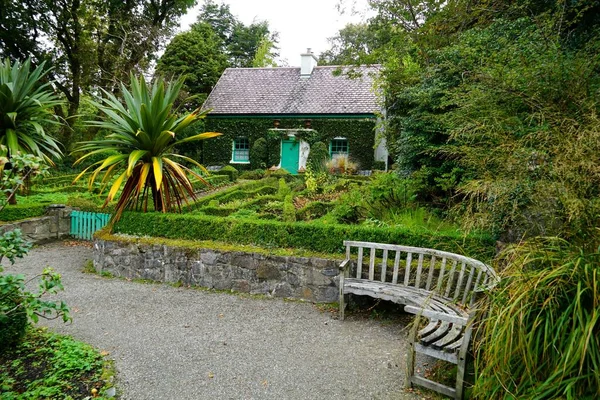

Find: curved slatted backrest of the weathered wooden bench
344;240;498;306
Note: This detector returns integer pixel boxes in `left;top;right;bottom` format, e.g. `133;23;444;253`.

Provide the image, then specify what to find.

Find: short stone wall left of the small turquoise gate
0;205;73;243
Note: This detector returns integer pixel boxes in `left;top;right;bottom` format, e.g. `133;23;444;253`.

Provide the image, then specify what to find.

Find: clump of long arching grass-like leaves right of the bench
474;238;600;399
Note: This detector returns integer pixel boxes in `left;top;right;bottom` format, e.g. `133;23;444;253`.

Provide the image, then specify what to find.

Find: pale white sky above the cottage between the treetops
181;0;368;66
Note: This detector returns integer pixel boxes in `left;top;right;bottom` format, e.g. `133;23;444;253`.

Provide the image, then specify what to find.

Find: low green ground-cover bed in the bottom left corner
0;330;114;400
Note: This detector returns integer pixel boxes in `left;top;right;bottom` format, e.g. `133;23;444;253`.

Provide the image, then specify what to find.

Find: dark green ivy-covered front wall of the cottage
199;117;376;169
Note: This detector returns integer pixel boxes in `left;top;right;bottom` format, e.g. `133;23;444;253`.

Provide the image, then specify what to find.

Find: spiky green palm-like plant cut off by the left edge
0;59;62;164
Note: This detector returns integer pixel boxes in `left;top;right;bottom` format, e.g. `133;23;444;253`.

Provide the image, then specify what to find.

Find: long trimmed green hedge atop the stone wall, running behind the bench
114;212;495;261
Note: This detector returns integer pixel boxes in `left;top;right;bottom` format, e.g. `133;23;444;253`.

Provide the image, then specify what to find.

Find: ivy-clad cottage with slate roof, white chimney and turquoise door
201;49;387;174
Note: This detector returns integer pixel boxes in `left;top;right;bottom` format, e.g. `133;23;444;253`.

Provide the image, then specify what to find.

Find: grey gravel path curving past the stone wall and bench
7;243;418;400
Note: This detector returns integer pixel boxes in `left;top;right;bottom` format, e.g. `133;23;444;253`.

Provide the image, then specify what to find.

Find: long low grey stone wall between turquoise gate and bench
94;238;340;302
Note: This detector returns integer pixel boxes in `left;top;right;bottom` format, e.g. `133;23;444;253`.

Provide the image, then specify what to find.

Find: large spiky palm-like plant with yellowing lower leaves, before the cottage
75;75;220;220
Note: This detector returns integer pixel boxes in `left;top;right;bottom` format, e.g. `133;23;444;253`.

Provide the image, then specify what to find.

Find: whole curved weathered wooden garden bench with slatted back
339;241;498;399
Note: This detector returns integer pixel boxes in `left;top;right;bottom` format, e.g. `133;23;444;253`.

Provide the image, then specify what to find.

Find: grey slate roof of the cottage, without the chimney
203;65;379;115
